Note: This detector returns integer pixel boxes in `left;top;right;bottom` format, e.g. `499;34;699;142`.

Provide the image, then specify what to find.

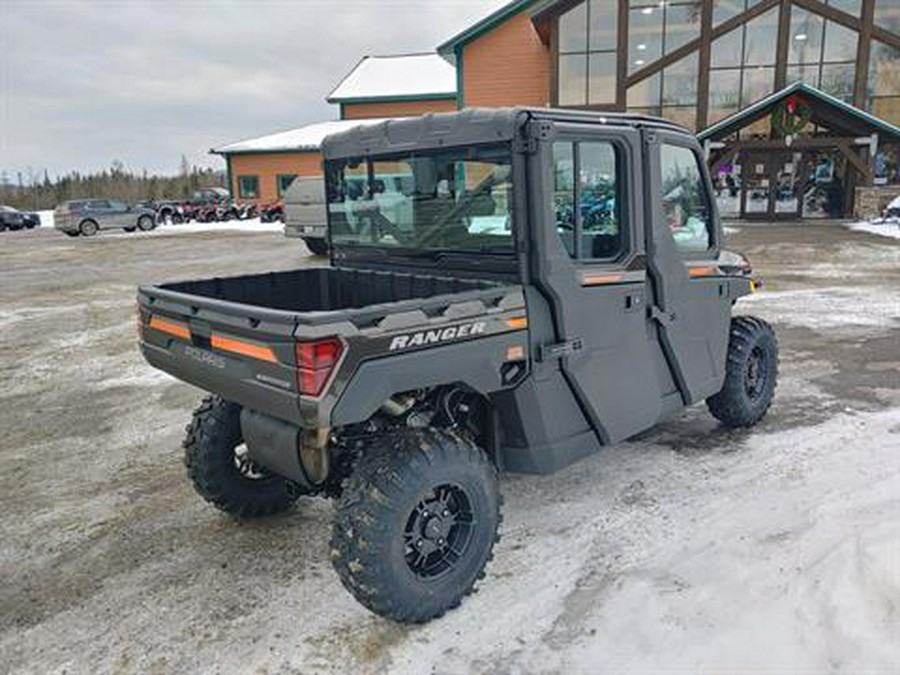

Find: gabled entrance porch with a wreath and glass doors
698;82;900;221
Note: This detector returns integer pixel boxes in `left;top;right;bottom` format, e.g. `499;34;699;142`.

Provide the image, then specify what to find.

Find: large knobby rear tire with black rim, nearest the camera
331;429;501;623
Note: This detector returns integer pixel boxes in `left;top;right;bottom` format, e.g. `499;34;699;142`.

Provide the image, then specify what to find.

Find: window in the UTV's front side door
660;144;713;253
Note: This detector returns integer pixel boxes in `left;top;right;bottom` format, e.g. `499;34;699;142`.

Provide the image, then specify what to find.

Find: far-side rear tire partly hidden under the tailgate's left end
184;396;297;518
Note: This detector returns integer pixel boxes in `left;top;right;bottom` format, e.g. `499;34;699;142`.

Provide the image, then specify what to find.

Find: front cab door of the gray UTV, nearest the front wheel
644;130;733;404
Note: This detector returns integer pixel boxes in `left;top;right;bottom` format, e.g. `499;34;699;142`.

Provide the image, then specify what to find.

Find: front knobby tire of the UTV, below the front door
706;316;778;428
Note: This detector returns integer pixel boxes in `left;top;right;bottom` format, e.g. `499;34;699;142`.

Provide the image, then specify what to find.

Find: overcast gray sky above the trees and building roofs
0;0;504;180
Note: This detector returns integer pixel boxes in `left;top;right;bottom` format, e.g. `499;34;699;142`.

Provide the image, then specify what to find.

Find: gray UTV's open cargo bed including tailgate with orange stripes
138;268;523;426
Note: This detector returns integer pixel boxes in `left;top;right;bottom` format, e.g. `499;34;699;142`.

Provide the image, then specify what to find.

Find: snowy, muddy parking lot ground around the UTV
0;225;900;673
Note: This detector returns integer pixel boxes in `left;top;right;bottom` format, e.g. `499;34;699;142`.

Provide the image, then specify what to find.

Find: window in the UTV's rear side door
553;142;624;260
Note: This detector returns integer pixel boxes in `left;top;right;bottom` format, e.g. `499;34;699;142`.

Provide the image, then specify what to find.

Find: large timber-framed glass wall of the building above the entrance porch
555;0;900;129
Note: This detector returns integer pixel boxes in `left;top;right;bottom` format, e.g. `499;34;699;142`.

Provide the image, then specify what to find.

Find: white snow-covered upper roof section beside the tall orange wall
326;54;456;103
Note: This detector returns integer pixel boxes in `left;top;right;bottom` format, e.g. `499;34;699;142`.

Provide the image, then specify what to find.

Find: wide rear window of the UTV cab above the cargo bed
326;145;514;254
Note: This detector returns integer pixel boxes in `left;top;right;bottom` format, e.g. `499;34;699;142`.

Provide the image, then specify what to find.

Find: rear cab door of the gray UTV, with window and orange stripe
529;123;667;444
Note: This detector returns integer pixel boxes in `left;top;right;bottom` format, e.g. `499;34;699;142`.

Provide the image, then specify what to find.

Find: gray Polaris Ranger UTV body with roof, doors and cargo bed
138;108;754;486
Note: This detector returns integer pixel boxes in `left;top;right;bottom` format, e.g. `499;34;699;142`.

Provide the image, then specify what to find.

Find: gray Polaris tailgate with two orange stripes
138;286;301;424
